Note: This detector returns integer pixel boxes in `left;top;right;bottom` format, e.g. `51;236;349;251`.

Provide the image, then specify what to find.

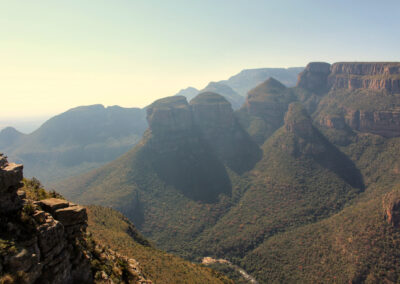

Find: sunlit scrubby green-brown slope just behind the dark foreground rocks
88;206;232;284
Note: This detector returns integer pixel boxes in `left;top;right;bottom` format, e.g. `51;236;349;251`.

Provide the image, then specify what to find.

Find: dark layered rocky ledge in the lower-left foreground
0;155;145;283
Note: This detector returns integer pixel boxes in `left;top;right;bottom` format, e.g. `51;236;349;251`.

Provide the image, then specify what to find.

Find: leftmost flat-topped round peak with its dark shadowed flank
143;96;231;202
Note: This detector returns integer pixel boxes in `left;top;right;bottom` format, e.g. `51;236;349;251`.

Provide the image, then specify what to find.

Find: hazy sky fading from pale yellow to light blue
0;0;400;121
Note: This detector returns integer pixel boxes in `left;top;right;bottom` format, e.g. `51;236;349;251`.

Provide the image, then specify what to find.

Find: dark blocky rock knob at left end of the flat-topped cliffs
297;62;331;93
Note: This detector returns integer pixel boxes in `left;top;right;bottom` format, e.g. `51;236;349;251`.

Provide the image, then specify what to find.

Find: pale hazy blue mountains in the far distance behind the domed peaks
0;65;302;185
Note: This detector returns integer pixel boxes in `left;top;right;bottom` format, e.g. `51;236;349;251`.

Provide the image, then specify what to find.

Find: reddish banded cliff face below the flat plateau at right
297;62;400;137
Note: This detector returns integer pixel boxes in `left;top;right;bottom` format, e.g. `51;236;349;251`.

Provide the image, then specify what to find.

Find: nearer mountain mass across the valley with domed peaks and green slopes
50;62;400;283
